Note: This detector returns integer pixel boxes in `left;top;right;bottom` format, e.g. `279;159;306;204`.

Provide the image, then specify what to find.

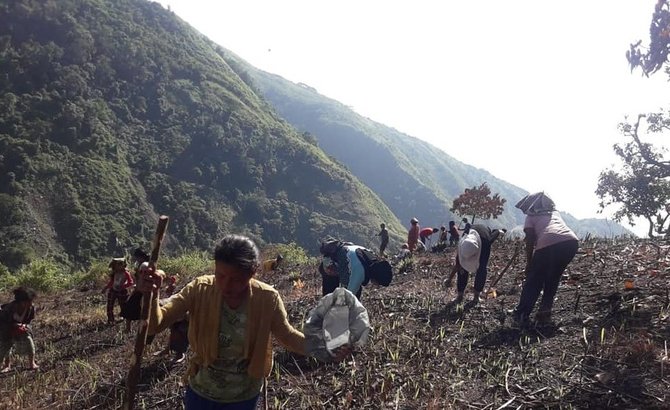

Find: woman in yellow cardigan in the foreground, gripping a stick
141;235;351;410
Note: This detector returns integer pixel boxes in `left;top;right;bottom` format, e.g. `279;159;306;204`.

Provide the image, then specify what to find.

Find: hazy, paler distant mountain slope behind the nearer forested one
220;56;632;236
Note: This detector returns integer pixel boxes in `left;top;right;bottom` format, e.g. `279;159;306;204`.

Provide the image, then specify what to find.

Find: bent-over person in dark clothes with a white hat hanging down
453;224;507;304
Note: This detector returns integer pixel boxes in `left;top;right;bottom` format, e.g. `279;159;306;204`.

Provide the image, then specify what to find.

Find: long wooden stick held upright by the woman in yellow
123;215;169;410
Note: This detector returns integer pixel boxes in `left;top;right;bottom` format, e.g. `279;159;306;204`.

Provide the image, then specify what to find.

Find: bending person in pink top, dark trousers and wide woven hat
512;192;579;328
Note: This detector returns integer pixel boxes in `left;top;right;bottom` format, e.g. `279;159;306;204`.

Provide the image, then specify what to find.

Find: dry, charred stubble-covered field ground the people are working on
0;237;670;409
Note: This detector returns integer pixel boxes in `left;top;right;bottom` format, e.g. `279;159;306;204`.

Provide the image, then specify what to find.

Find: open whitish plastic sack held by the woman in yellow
303;287;370;361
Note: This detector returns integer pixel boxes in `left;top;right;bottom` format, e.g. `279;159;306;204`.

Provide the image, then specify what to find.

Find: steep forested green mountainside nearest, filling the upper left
0;0;404;267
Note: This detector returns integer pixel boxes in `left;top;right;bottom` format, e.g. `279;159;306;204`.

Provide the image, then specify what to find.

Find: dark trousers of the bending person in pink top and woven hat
516;240;579;318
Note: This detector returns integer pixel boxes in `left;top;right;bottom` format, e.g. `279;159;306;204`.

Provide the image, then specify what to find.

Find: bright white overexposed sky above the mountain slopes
159;0;670;234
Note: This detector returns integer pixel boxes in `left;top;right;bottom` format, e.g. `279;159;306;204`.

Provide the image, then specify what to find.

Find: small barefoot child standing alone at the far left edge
0;287;39;373
